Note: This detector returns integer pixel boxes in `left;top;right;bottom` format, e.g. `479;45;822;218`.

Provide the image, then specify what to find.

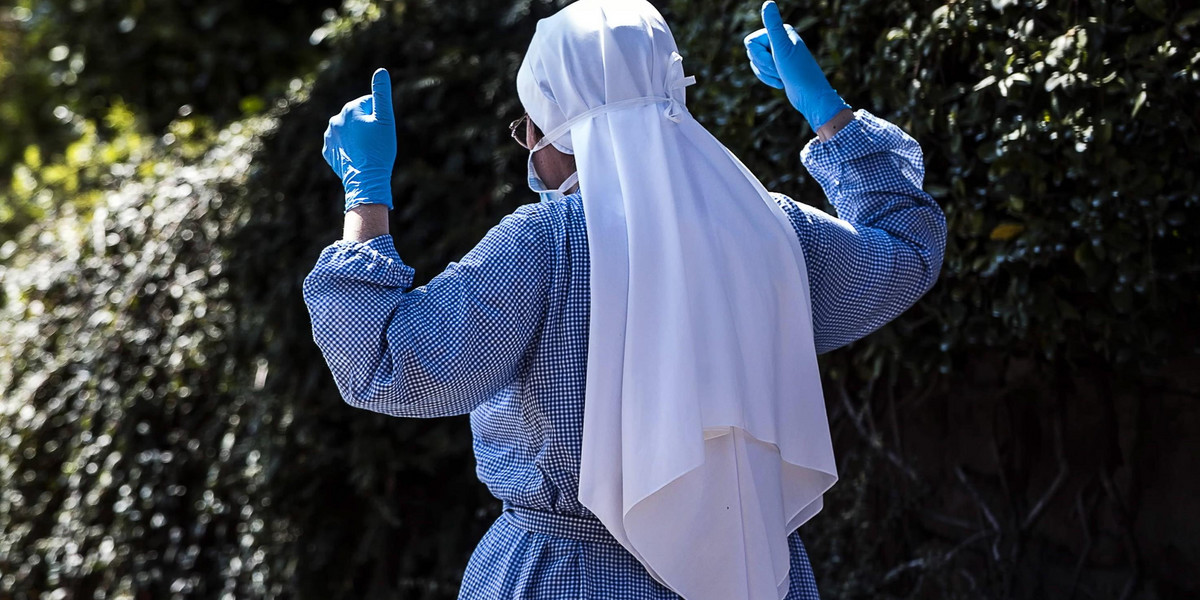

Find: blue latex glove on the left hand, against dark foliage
320;68;396;212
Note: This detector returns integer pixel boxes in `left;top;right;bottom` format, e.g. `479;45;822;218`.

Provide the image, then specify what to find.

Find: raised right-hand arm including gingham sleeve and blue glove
744;0;946;352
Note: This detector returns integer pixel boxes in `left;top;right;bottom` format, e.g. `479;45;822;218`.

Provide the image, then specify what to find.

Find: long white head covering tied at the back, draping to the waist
517;0;838;600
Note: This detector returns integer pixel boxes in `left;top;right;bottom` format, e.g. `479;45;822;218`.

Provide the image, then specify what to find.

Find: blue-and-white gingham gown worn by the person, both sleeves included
304;110;946;600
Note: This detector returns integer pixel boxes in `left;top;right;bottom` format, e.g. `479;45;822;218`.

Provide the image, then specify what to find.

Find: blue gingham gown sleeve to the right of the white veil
774;110;946;353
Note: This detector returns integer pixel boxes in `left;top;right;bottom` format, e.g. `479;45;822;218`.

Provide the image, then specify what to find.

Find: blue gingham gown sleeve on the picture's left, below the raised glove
304;203;551;418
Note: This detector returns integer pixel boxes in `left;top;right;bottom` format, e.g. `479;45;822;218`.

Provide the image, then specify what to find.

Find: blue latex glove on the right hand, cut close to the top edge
745;1;850;131
